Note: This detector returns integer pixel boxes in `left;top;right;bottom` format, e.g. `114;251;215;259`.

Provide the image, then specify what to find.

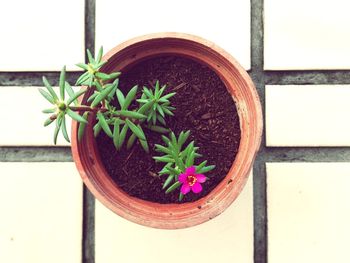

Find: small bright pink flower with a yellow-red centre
179;166;207;195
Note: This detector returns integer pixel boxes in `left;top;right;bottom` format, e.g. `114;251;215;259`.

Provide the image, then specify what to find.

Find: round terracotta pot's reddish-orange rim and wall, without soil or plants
72;33;263;229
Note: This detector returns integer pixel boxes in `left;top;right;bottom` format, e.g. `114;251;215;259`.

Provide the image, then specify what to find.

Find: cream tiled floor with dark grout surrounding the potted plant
0;0;350;263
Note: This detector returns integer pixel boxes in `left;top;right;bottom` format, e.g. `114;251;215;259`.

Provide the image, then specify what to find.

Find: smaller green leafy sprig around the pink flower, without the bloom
153;131;215;199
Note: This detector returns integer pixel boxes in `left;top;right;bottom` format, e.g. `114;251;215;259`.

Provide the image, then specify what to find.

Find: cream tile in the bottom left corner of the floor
0;162;82;263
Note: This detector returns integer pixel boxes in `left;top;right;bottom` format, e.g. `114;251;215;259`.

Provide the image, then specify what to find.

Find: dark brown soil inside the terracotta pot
97;56;241;203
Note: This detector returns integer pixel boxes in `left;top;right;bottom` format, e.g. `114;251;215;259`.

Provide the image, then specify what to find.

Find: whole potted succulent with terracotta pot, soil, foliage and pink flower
41;33;262;229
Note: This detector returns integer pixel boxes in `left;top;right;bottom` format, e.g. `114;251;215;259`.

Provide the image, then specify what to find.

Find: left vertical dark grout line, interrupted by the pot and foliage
82;0;96;263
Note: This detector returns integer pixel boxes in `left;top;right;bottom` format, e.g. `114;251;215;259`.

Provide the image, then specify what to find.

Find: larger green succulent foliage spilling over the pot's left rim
39;47;175;152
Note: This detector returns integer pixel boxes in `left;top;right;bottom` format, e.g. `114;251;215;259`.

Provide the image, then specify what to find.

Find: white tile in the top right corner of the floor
264;0;350;70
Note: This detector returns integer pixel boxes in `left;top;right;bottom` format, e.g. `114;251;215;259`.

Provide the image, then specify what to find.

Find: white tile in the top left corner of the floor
0;0;84;71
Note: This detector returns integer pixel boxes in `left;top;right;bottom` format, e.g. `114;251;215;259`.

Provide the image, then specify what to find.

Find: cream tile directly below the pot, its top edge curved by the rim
95;173;253;263
